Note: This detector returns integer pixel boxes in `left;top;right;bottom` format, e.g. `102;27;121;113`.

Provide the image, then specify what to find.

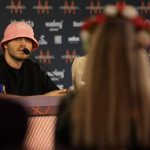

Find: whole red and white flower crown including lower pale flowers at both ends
81;3;150;47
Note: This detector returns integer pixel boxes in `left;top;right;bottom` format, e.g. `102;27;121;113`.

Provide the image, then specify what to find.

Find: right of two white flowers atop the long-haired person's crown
122;6;139;19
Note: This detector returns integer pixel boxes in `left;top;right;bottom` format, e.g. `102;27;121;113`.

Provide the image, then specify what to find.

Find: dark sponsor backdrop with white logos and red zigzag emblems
0;0;150;88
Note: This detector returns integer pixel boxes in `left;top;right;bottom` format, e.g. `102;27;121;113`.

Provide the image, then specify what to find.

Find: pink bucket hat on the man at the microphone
1;22;39;50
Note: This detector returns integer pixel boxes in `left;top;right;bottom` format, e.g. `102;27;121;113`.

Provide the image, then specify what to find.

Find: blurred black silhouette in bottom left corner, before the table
0;98;28;150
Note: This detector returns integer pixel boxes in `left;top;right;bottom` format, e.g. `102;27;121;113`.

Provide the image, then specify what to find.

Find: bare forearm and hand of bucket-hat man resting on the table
44;89;68;96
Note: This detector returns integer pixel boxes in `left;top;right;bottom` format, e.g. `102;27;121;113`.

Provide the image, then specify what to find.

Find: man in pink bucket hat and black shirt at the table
0;22;66;96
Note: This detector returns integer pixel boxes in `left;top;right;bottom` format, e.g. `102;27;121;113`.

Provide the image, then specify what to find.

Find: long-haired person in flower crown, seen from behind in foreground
55;5;150;150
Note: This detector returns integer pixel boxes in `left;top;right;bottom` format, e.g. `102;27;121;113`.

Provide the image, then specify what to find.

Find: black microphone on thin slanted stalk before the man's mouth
23;48;67;89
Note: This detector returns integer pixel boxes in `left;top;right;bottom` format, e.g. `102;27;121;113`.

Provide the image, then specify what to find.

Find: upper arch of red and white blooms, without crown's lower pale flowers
81;4;150;32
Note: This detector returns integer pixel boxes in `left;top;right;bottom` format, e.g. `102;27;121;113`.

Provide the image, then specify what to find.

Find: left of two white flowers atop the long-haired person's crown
104;5;118;17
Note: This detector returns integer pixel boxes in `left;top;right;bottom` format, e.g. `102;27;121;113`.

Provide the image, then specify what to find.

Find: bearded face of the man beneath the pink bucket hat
4;37;33;61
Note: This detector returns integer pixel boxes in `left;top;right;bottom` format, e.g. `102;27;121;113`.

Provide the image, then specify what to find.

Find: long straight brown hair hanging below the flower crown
72;18;150;149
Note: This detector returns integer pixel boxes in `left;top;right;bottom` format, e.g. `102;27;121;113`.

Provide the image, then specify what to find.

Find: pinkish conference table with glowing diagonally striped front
2;95;61;150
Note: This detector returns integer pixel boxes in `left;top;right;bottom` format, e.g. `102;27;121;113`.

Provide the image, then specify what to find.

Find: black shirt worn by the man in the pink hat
0;55;59;96
